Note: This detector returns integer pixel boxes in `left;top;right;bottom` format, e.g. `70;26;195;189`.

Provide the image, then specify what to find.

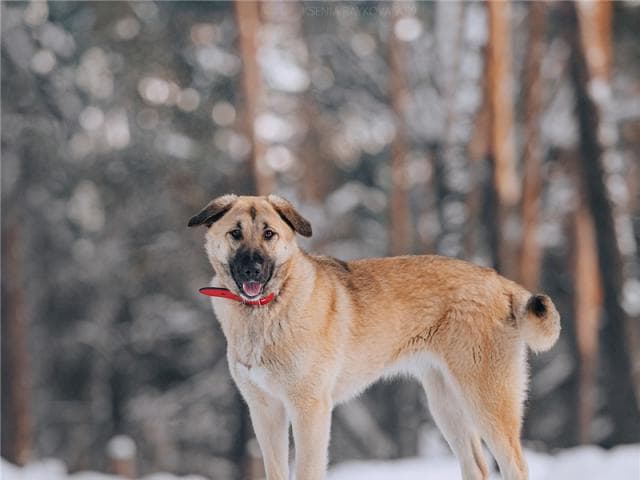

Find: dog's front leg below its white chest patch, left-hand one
238;382;289;480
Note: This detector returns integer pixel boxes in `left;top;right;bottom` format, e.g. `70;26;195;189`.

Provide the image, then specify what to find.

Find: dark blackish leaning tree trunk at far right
565;3;640;445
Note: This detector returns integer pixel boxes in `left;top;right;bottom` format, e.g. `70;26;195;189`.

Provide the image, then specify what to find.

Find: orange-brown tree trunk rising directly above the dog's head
235;0;274;195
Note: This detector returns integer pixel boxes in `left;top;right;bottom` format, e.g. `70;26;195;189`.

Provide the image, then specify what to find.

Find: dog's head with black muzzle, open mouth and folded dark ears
189;195;311;299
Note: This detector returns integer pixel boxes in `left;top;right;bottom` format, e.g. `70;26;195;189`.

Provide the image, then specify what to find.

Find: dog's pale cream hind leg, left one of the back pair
422;367;489;480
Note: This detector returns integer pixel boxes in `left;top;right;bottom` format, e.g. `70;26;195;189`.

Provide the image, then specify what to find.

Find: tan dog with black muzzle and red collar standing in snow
189;195;560;480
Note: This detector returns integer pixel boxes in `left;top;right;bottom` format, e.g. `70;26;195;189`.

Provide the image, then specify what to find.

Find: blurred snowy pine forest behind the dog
1;1;640;479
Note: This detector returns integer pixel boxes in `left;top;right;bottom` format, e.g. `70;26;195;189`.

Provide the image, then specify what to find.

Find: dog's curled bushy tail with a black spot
512;289;560;352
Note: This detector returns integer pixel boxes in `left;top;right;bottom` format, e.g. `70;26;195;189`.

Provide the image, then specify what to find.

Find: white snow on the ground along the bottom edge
1;445;640;480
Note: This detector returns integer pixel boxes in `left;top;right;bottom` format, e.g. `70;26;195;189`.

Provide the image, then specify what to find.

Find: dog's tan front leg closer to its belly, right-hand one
291;395;333;480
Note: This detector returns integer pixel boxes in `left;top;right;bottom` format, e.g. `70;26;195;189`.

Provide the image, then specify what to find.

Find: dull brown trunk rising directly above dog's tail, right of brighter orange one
518;1;545;291
